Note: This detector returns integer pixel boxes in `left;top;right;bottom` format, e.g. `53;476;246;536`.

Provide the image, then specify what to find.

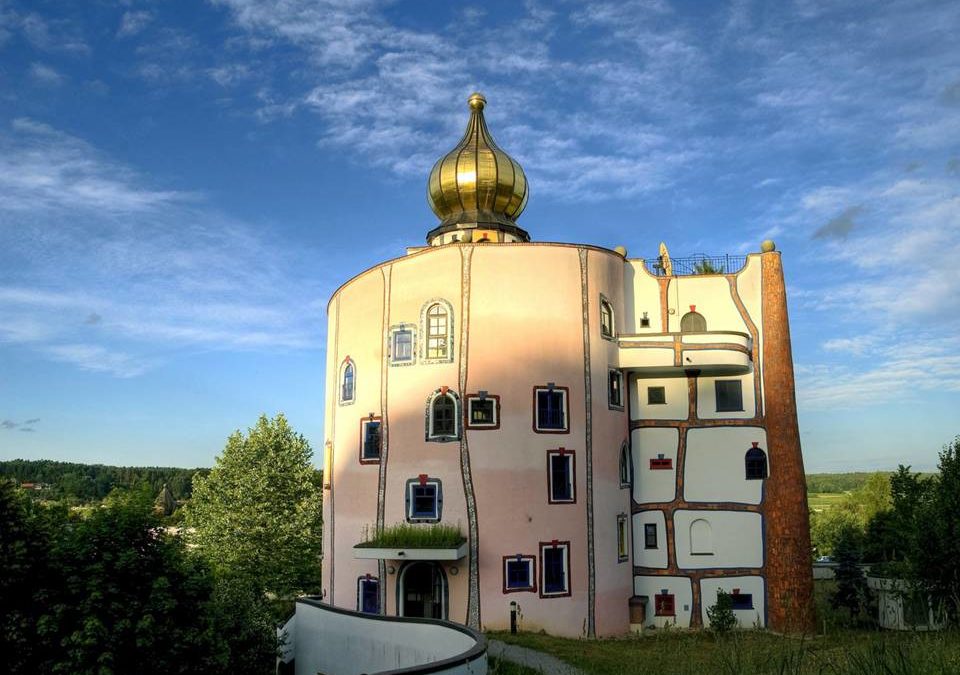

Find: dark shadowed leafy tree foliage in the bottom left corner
0;483;276;675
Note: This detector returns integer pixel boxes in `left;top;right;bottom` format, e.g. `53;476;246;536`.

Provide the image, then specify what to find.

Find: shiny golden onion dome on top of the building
427;93;530;243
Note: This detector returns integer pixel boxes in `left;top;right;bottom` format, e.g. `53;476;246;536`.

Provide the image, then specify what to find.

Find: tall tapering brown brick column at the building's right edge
761;252;815;633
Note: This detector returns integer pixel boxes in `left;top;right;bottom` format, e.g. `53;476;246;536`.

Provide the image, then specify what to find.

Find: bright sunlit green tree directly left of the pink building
186;414;323;598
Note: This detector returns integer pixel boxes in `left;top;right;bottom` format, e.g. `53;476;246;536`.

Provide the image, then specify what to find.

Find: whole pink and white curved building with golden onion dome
323;94;812;637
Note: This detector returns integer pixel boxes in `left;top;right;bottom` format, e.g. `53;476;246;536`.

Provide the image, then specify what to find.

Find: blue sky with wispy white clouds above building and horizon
0;0;960;471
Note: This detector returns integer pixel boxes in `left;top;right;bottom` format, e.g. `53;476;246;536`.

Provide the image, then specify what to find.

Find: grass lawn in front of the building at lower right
489;582;960;675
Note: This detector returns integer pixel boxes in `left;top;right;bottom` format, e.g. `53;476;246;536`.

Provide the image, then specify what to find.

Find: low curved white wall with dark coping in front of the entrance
294;602;487;675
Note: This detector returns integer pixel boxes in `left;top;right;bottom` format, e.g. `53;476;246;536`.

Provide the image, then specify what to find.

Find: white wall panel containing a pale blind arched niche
673;510;763;569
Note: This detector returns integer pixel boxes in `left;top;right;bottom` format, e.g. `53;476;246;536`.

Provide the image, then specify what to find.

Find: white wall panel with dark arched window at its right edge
683;427;770;504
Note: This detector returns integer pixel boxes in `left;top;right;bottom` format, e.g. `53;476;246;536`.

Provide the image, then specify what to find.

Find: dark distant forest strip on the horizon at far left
0;459;210;502
